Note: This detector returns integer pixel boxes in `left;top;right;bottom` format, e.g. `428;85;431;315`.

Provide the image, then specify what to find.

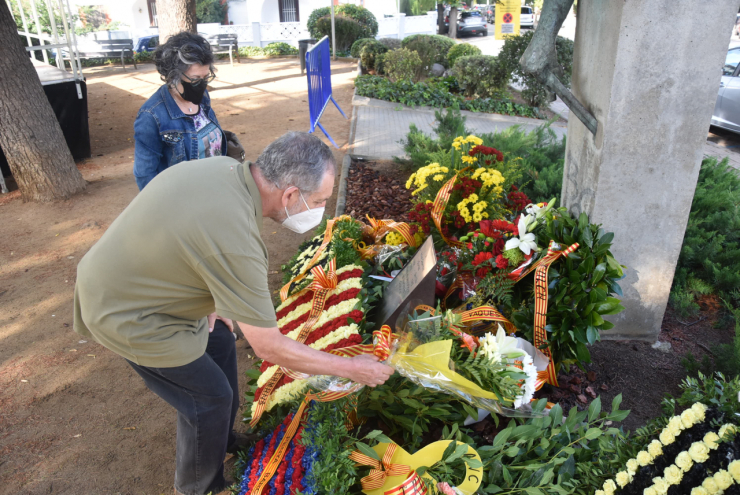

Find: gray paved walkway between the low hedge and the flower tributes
350;96;567;159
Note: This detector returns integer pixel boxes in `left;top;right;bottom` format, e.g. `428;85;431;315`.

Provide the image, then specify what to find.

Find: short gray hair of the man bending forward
255;132;336;193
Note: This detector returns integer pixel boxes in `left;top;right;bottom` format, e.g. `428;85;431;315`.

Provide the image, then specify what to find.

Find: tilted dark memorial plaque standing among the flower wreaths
375;236;437;331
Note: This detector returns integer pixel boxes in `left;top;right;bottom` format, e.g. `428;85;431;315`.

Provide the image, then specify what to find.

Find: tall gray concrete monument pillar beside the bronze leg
562;0;740;341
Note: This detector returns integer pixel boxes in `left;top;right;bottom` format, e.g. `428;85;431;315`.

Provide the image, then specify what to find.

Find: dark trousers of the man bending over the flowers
129;320;239;495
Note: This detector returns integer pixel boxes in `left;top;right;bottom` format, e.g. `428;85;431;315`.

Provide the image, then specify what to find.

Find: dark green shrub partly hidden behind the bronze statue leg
498;31;573;107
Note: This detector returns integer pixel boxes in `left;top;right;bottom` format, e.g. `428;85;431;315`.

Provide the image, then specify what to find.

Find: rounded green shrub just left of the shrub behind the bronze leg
452;55;507;98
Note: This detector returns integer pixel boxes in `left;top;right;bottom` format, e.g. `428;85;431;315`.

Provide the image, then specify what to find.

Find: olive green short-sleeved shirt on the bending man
74;156;277;368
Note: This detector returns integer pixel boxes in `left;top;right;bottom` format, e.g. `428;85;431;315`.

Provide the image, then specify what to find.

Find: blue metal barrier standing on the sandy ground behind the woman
306;36;347;148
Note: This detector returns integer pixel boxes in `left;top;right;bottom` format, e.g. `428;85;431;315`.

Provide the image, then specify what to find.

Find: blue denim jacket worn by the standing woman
134;84;227;190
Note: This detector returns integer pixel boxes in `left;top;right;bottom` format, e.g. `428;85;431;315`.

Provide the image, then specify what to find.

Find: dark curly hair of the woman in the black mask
154;31;215;86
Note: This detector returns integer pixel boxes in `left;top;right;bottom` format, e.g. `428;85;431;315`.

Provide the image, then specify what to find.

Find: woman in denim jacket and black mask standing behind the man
134;32;244;190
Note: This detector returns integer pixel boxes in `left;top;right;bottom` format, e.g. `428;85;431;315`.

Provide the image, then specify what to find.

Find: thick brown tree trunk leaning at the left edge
0;2;87;201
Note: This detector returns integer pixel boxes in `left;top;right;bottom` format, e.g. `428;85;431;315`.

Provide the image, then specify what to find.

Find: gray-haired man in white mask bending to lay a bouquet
74;132;393;495
